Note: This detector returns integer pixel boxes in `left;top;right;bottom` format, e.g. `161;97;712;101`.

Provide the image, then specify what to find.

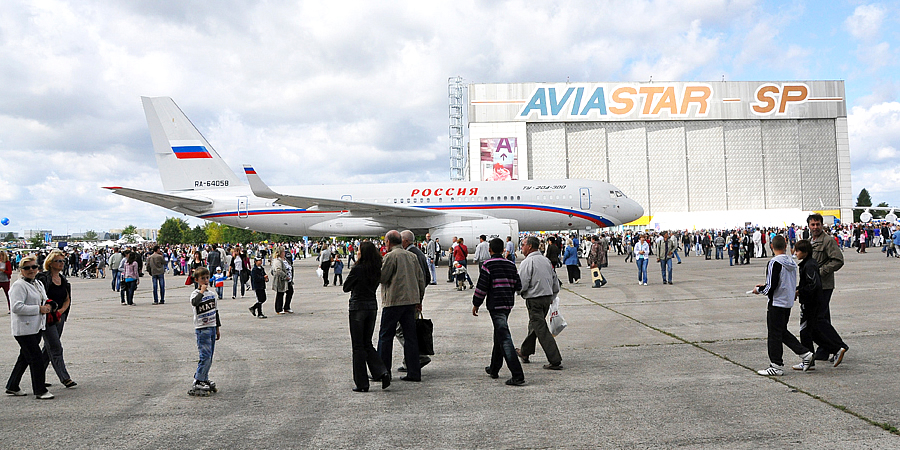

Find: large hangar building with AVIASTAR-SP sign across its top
468;81;852;228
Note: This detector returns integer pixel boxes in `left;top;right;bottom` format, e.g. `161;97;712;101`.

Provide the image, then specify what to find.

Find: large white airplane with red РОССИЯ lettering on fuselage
105;97;644;248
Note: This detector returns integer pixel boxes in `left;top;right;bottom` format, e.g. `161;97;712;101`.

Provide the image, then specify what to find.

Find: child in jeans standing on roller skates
188;267;221;396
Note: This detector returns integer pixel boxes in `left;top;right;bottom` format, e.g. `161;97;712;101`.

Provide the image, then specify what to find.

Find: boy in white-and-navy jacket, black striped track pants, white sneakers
753;235;813;376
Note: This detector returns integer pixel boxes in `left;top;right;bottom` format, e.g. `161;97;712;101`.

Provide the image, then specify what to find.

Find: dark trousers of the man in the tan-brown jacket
378;305;422;380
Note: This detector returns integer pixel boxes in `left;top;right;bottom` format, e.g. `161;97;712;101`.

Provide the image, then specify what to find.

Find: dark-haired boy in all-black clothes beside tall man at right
792;239;849;371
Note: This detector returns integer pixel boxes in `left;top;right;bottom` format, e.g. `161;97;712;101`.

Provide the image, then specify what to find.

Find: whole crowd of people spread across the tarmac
0;218;900;399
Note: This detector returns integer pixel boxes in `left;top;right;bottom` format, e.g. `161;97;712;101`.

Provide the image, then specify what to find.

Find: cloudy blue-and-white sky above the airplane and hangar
0;0;900;234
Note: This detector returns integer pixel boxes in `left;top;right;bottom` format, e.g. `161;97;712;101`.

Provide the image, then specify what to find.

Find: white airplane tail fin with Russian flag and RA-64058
141;97;244;191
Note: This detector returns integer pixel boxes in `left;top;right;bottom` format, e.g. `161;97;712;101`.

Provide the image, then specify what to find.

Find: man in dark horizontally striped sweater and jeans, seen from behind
472;238;525;386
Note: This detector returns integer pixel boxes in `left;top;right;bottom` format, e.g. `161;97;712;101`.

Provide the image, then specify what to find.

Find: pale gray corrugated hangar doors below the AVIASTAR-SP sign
527;119;840;214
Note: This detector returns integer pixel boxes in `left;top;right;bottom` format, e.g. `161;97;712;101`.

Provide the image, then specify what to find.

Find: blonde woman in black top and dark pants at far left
36;250;78;389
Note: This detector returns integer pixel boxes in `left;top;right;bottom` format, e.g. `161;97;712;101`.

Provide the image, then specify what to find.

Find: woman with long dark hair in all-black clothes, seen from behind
344;241;391;392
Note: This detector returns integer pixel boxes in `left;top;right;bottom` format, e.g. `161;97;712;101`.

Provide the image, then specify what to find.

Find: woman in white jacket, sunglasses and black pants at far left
6;255;53;400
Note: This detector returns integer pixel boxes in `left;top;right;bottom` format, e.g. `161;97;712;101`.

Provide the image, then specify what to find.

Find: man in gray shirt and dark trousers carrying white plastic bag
516;236;563;370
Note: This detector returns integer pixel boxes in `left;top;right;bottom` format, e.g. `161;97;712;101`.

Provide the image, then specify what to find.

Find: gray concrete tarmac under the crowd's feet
0;250;900;449
